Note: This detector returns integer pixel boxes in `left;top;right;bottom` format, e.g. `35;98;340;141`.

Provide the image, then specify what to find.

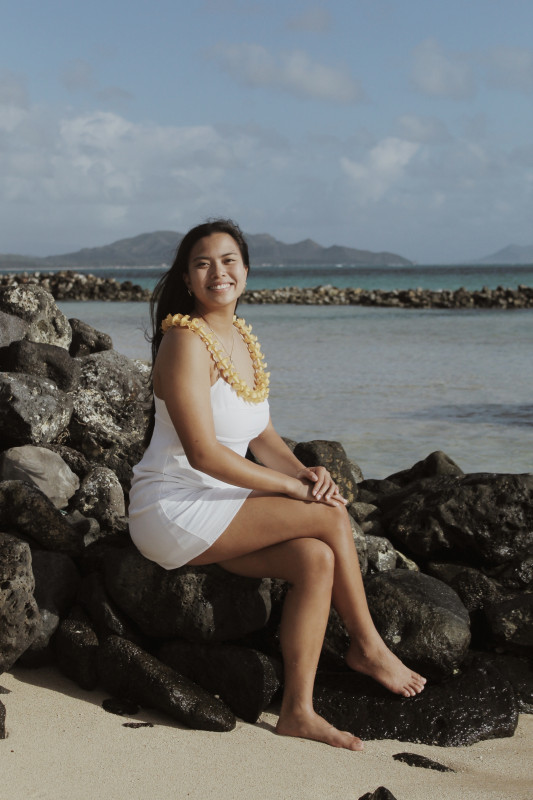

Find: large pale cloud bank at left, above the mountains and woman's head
0;106;287;255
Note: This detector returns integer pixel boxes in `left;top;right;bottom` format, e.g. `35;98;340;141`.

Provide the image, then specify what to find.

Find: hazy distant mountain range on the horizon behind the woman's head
0;231;413;270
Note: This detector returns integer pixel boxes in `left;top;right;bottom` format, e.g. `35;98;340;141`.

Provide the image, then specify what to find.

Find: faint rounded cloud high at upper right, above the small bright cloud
411;39;476;100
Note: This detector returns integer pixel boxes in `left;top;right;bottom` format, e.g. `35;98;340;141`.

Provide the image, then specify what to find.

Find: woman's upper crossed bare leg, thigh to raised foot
191;493;426;697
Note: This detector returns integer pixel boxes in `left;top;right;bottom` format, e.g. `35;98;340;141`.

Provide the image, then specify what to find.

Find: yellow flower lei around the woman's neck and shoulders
161;314;270;403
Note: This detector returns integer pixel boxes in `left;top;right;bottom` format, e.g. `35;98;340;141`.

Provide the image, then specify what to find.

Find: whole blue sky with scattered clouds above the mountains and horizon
0;0;533;263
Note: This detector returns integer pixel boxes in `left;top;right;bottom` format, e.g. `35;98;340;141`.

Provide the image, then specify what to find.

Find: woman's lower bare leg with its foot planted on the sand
220;538;363;750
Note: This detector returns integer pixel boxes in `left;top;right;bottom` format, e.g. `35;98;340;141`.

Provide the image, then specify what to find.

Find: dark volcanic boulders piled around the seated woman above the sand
0;284;533;745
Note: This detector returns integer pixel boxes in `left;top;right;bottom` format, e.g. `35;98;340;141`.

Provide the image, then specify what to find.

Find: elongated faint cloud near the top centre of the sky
211;44;365;104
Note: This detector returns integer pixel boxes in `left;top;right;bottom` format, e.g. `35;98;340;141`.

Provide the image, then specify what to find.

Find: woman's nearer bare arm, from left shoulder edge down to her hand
154;328;340;504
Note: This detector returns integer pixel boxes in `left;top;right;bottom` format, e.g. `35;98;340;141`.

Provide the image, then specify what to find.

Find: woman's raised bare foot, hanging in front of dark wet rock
346;638;426;697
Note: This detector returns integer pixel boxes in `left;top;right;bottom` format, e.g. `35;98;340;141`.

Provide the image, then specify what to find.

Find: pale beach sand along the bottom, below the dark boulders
0;668;533;800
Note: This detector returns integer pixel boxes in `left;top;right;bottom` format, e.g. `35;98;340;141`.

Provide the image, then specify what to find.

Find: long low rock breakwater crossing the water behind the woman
0;270;533;310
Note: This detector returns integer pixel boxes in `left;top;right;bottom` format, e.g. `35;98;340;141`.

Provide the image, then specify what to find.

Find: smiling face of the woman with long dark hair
183;233;248;312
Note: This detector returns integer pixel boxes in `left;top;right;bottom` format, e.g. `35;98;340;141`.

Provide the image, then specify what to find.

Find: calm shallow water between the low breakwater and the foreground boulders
55;288;533;478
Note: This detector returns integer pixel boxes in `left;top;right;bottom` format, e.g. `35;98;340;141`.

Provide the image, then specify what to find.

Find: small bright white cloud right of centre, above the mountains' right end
341;137;420;205
